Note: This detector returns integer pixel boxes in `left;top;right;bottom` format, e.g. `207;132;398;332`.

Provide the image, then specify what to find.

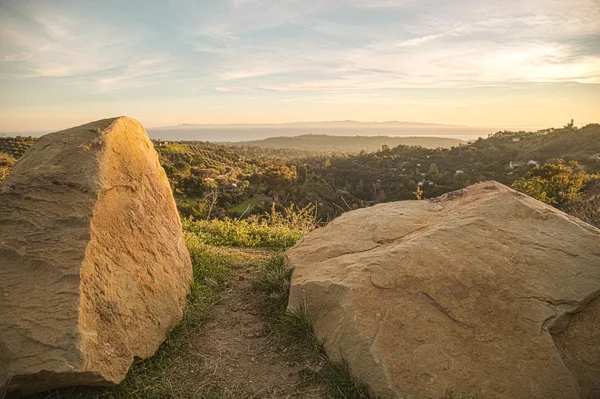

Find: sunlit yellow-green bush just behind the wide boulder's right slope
512;159;591;208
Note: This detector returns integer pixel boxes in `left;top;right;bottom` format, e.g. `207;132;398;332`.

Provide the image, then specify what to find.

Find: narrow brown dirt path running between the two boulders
166;250;324;399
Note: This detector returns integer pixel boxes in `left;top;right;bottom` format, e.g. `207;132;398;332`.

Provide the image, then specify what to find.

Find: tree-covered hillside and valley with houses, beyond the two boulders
0;124;600;221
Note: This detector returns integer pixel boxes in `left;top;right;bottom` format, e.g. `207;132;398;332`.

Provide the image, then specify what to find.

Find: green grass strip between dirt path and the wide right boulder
253;254;374;399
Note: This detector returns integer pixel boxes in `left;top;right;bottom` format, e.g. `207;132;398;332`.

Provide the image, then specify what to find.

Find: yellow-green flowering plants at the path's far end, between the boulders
182;205;314;249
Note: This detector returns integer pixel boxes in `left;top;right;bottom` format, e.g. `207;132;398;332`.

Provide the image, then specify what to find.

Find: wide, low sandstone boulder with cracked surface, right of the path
286;182;600;399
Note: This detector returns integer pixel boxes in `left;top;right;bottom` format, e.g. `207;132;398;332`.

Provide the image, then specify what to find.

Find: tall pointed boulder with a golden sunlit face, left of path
0;117;192;396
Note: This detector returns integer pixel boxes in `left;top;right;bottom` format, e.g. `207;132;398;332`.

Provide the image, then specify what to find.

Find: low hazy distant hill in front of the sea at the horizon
228;134;465;153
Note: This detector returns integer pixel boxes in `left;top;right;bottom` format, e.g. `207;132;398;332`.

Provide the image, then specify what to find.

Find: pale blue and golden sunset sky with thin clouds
0;0;600;132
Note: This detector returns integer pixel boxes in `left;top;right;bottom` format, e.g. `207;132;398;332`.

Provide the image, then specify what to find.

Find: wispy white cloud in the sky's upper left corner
0;2;175;91
